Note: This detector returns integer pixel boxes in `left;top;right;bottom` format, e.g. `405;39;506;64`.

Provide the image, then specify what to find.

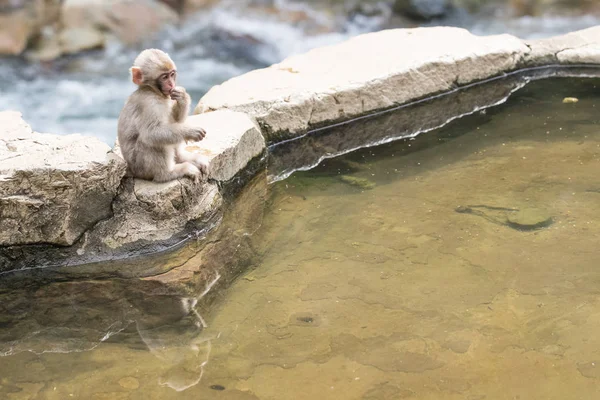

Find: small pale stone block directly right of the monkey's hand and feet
186;110;265;182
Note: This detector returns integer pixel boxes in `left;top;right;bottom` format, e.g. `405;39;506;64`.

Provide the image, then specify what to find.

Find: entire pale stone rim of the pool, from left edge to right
0;27;600;279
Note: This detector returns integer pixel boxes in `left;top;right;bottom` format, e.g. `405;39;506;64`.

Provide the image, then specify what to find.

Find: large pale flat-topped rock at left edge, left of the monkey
0;111;125;246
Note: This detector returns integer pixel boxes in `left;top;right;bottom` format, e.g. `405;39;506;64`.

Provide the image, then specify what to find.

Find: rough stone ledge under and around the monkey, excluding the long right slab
0;110;265;272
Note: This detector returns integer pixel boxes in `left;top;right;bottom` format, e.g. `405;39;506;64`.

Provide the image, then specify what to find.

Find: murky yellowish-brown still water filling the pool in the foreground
0;79;600;400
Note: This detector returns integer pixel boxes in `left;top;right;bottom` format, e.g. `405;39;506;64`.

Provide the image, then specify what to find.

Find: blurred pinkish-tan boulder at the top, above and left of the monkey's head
61;0;179;44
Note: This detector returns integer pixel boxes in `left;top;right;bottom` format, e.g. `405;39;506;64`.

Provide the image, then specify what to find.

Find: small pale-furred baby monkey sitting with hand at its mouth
118;49;208;182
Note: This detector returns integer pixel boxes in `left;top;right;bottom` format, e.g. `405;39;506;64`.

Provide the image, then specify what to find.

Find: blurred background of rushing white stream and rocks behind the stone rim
0;0;600;145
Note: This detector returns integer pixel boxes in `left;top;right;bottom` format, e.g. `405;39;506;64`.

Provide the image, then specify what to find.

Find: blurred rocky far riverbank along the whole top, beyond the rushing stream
0;0;600;62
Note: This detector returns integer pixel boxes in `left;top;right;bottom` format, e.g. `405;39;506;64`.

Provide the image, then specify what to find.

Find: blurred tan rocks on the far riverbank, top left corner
0;0;215;61
